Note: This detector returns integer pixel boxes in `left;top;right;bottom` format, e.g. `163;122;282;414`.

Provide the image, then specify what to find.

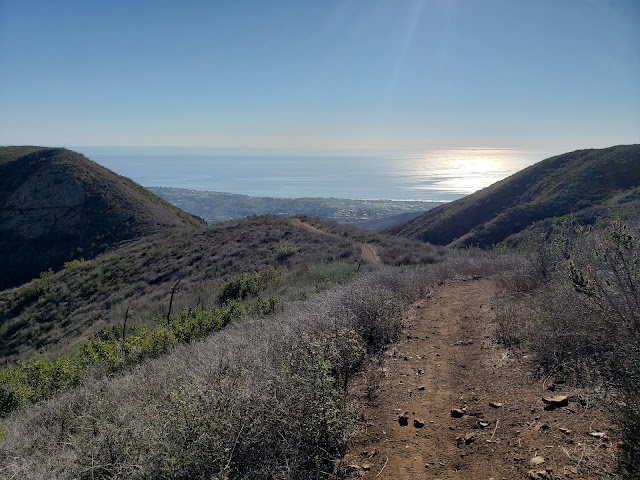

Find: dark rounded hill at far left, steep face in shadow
0;147;204;289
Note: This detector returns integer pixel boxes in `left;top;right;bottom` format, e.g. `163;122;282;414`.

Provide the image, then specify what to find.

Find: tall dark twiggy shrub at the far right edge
568;222;640;475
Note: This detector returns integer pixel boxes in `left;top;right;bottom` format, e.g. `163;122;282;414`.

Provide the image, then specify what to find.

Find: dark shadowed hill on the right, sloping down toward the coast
385;145;640;247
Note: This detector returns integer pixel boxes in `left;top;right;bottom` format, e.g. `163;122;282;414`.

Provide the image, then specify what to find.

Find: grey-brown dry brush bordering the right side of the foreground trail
497;223;640;478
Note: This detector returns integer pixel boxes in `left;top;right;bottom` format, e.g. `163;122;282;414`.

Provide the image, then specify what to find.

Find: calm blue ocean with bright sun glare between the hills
71;147;551;201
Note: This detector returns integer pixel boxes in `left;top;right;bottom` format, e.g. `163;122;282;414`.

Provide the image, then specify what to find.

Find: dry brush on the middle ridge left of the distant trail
0;217;359;362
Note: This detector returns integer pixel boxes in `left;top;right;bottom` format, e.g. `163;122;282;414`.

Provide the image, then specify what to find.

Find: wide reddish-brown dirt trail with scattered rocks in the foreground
346;279;617;480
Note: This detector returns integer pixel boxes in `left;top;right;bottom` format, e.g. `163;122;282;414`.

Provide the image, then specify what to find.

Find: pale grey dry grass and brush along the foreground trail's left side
0;252;511;479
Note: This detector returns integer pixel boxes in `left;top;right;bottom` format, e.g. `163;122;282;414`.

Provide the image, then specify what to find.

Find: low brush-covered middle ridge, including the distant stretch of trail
0;216;442;364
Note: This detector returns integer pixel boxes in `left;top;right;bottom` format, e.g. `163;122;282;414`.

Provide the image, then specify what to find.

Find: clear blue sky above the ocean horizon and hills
0;0;640;149
